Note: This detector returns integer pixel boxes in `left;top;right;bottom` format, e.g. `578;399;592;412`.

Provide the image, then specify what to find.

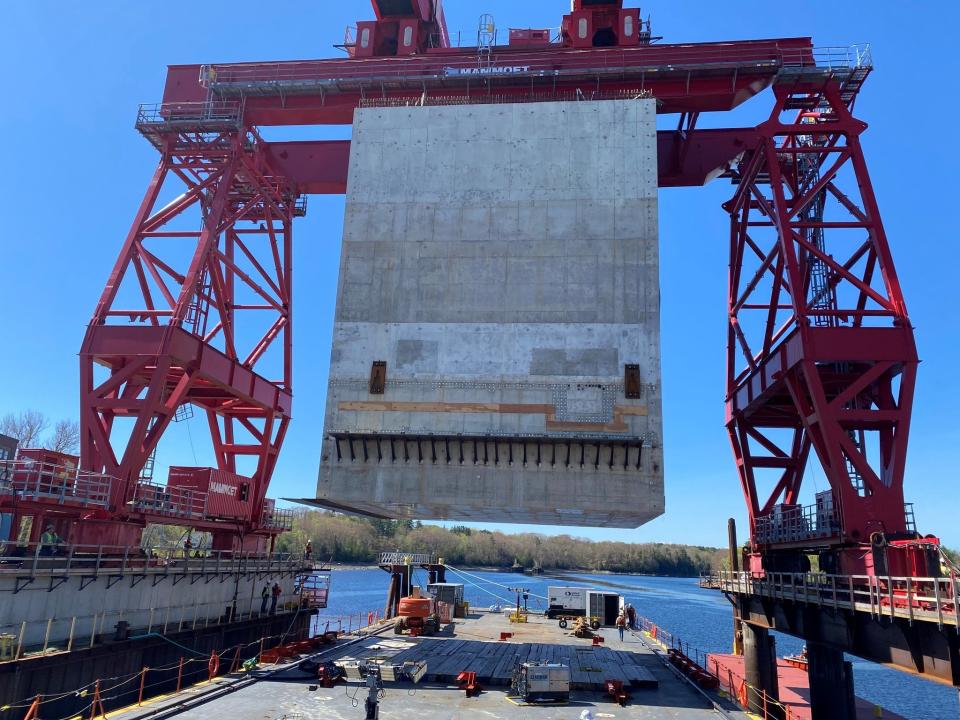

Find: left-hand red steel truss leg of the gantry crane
80;129;303;512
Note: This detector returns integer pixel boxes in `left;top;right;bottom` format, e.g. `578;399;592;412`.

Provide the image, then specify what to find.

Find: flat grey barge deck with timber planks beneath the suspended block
110;612;748;720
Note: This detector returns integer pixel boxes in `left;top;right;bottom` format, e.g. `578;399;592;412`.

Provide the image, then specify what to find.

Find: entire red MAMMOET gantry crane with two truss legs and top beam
0;0;937;575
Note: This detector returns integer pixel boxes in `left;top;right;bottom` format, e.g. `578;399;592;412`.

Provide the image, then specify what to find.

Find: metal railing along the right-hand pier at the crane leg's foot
700;571;960;628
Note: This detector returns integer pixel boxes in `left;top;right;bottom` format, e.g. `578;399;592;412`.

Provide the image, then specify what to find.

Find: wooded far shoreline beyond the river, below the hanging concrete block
277;511;726;577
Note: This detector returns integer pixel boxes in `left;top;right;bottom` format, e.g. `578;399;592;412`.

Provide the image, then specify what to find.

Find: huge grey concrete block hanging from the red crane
317;100;664;527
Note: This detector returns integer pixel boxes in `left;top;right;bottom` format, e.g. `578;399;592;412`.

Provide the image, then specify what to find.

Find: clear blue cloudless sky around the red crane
0;0;960;546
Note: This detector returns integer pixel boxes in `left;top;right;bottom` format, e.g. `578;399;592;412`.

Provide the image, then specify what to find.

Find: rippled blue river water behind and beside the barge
320;569;960;720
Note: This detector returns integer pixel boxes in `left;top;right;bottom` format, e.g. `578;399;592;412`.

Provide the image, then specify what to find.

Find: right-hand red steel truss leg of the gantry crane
724;83;918;547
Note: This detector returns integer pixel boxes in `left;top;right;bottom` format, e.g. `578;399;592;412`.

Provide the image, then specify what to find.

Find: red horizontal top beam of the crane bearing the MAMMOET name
163;37;818;126
